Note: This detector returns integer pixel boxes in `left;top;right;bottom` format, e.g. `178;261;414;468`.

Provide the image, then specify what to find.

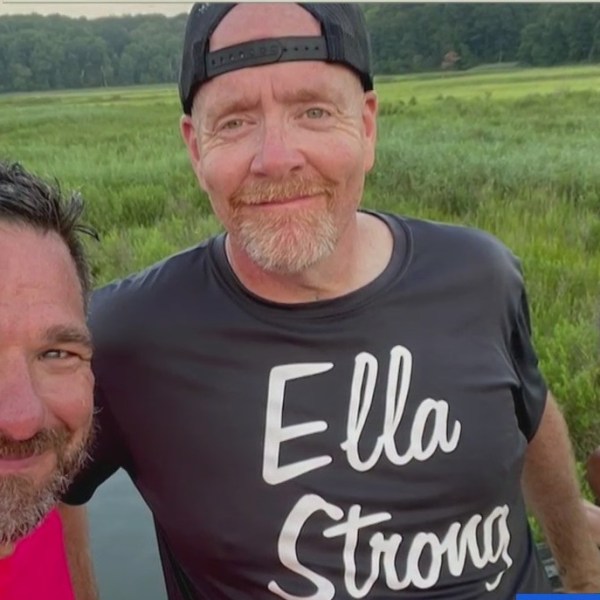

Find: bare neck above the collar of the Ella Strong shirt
226;213;393;304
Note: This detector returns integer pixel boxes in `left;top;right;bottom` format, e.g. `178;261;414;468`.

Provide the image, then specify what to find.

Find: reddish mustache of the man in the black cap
231;177;333;206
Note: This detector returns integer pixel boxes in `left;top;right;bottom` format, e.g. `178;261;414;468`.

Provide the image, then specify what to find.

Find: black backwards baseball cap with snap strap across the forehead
179;3;373;115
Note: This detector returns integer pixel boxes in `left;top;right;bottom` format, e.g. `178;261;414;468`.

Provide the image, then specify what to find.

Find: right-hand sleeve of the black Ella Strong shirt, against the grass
510;279;548;441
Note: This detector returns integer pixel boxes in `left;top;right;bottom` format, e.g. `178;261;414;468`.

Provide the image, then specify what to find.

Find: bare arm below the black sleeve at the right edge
523;394;600;592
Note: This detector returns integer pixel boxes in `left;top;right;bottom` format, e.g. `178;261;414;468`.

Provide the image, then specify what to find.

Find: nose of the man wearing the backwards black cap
250;122;305;180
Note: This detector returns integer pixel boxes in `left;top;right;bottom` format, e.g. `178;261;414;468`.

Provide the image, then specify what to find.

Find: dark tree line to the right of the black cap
363;3;600;73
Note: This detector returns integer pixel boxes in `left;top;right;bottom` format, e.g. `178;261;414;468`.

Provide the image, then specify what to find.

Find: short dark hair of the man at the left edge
0;161;98;304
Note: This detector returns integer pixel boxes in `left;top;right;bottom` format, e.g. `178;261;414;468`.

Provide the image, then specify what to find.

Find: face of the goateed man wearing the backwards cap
182;4;376;273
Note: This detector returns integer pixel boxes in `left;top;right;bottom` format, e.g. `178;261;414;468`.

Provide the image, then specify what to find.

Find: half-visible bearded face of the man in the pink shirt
0;222;93;545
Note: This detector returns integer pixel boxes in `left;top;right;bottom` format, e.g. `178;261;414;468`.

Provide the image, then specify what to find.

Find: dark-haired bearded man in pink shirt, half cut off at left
0;163;93;600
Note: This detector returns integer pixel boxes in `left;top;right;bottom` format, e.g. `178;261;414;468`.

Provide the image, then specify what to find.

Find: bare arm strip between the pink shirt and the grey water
58;503;98;600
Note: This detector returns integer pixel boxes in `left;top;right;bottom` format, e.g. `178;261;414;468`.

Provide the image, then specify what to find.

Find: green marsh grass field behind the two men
0;67;600;472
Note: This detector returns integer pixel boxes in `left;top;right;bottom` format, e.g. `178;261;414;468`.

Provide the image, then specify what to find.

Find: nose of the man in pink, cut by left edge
0;360;45;440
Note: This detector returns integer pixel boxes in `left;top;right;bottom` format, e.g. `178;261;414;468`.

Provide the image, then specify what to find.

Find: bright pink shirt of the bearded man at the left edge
0;510;75;600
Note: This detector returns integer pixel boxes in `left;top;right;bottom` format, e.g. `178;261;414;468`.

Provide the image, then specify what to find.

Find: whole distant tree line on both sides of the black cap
0;3;600;92
